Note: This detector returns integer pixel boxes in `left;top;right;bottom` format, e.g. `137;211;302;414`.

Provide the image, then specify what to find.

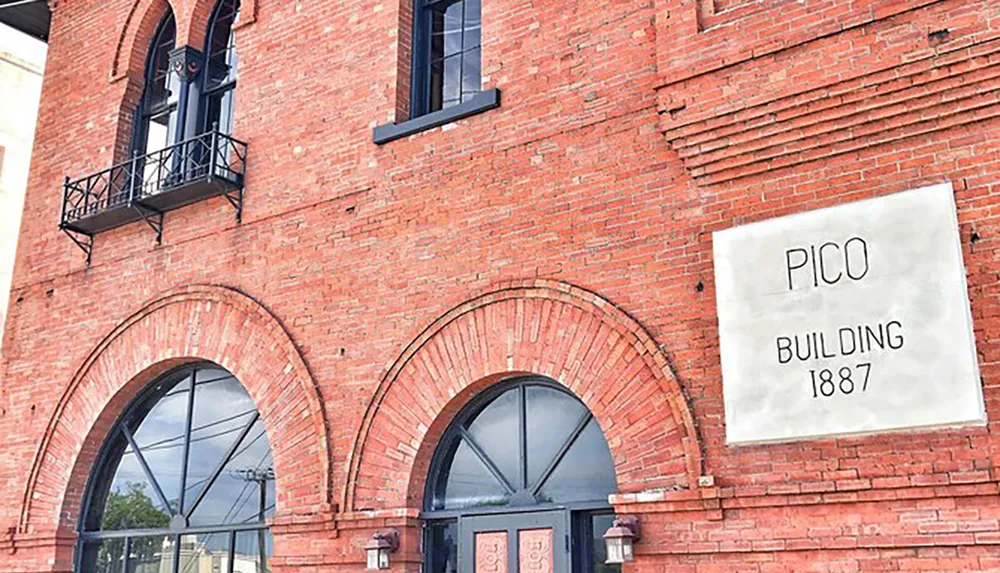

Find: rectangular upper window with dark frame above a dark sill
411;0;482;117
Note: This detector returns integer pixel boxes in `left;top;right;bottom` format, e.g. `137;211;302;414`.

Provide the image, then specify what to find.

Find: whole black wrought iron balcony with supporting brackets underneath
59;128;247;263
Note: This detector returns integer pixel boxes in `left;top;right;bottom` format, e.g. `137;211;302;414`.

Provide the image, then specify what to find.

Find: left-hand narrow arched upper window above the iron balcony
132;8;180;159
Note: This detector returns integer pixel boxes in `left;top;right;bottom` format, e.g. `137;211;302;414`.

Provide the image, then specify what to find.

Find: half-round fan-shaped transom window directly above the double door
426;379;617;511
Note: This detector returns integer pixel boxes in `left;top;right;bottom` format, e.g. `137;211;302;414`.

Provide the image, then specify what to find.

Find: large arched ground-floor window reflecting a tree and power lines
77;364;275;573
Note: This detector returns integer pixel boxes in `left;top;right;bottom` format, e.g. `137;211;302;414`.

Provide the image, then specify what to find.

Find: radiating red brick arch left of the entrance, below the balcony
20;286;331;533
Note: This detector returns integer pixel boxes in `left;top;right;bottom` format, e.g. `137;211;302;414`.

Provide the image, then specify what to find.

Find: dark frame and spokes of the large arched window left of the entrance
73;362;277;573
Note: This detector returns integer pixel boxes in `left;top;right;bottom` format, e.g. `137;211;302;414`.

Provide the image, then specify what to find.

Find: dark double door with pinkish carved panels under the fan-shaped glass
458;511;570;573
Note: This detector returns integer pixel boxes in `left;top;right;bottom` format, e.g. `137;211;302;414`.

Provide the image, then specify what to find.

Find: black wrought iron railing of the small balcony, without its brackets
62;129;247;229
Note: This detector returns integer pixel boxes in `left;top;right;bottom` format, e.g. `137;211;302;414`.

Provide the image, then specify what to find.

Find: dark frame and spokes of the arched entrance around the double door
420;376;620;573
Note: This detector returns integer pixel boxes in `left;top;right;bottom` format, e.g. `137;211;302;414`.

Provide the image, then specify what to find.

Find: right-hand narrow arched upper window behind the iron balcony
202;0;240;134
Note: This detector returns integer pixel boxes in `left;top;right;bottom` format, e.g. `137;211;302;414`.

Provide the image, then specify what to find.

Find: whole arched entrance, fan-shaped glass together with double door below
423;378;617;573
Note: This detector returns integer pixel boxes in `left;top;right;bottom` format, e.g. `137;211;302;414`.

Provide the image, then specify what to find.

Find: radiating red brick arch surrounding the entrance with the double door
343;280;702;511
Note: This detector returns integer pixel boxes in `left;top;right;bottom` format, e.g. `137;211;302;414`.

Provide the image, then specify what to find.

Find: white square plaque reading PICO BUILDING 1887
713;184;986;444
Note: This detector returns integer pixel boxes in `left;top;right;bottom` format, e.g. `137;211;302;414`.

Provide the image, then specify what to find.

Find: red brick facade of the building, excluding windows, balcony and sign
0;0;1000;573
